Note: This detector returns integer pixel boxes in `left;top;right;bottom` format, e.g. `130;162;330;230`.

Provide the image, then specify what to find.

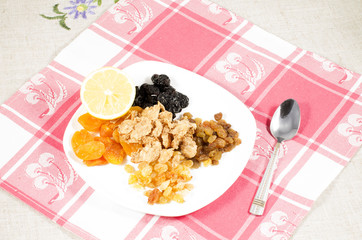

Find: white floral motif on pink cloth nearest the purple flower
109;0;153;34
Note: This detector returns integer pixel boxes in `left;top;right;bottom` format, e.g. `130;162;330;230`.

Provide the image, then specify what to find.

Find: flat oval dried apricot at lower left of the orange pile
74;141;106;160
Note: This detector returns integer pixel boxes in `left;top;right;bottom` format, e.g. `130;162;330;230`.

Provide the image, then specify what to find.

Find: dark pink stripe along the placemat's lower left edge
0;181;56;219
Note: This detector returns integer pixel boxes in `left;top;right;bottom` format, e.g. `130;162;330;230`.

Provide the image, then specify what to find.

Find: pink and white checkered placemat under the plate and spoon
0;0;362;240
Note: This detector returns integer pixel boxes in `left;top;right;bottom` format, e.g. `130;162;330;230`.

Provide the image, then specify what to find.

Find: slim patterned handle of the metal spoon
249;142;280;215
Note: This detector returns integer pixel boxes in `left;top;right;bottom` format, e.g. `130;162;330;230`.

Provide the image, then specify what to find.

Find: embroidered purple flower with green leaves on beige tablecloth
40;0;119;30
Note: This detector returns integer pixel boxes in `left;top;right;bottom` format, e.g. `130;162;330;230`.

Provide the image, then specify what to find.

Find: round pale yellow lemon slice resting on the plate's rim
80;67;136;120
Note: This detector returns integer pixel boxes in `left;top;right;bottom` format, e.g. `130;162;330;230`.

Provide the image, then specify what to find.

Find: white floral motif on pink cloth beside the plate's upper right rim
215;52;265;94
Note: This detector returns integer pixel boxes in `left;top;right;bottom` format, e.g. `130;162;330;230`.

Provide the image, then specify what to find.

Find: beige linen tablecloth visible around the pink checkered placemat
0;0;362;240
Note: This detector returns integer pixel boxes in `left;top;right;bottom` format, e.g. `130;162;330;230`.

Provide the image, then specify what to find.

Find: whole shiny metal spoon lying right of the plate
249;99;300;215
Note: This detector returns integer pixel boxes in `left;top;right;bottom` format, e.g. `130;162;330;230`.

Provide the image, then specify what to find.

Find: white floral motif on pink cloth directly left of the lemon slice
20;73;67;118
